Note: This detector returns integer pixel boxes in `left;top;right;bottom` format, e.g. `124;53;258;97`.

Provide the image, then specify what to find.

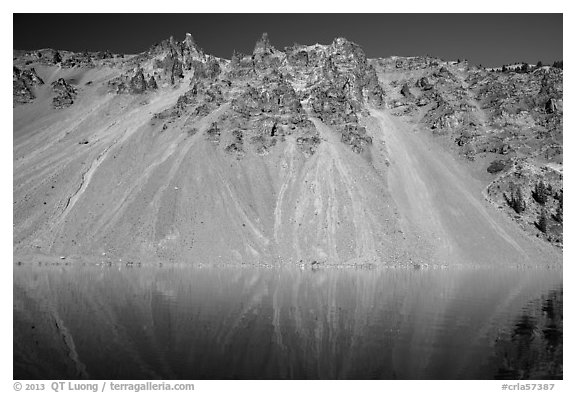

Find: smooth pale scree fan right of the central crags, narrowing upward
372;110;562;266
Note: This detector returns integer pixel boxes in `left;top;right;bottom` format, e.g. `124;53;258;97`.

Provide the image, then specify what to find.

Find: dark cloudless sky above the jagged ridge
14;14;563;66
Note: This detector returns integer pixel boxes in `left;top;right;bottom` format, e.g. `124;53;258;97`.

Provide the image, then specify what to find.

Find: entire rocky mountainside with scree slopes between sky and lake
13;34;562;266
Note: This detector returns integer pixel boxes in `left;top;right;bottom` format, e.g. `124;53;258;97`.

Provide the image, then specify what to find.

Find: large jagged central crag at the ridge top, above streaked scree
148;33;384;158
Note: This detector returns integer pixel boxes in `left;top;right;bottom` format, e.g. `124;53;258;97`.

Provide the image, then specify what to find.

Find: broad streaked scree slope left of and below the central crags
14;67;418;263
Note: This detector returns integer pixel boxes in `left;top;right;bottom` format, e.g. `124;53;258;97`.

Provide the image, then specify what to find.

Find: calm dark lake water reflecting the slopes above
14;264;562;379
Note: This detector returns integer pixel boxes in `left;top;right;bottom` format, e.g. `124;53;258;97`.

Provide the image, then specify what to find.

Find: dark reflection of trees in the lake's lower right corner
495;289;563;379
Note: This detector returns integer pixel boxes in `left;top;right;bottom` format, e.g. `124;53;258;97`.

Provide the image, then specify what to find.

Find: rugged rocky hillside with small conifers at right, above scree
372;57;563;244
